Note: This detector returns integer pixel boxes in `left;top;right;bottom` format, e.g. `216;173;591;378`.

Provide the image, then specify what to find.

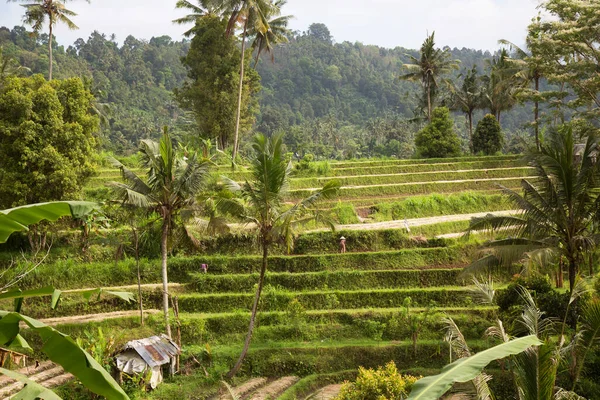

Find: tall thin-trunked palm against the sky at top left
9;0;84;81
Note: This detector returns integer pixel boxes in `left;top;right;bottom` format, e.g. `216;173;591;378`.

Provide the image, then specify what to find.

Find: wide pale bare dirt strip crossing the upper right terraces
309;210;517;232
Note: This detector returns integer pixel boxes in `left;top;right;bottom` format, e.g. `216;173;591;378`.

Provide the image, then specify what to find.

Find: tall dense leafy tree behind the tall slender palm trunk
176;16;260;149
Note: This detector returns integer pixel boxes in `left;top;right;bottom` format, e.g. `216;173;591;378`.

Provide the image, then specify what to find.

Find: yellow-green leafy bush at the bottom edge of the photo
335;361;418;400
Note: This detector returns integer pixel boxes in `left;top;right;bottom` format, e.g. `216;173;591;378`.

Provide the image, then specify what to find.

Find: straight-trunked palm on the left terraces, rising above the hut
111;127;210;337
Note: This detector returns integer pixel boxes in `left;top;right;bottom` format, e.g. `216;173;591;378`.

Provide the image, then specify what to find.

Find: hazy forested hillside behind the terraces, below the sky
0;24;531;158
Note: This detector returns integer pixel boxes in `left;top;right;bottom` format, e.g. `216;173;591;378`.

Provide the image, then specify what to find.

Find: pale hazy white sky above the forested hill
0;0;539;50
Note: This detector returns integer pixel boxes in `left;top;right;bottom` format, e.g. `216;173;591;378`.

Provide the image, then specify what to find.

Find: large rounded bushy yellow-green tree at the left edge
0;75;98;208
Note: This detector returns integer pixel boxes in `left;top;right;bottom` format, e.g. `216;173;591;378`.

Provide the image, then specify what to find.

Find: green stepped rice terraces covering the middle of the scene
9;156;531;399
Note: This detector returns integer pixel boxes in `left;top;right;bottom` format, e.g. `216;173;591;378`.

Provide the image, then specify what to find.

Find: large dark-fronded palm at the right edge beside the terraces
467;126;600;292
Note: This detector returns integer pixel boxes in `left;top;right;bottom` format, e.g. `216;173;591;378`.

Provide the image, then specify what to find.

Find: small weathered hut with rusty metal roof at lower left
115;335;181;389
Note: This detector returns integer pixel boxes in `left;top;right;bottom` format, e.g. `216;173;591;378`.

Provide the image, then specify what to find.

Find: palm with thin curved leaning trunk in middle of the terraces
219;135;340;377
